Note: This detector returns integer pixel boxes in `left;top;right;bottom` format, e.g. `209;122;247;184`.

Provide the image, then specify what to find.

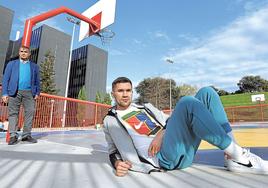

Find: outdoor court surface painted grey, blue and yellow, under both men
0;123;268;188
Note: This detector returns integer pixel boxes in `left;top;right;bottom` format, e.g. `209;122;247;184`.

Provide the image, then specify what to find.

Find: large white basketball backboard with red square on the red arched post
79;0;116;41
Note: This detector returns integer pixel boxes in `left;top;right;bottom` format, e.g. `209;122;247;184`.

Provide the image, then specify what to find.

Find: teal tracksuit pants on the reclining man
157;87;232;170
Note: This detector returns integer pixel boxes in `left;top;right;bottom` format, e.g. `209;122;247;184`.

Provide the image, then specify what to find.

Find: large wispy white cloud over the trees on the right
163;6;268;90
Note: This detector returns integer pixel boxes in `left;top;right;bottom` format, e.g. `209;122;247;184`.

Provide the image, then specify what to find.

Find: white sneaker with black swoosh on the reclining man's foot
226;149;268;174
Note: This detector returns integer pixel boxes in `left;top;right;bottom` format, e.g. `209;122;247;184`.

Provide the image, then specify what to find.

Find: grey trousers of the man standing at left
8;90;35;138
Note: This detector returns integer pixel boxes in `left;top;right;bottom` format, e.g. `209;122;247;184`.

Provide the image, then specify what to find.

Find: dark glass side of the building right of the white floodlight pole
68;46;88;98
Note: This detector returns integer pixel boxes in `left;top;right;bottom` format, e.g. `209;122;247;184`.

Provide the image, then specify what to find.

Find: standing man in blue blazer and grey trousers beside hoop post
2;46;40;145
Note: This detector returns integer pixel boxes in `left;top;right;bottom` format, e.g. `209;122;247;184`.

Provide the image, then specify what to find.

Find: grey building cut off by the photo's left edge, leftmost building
0;5;14;81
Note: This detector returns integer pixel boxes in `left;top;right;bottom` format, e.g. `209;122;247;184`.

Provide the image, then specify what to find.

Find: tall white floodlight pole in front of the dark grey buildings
62;17;80;127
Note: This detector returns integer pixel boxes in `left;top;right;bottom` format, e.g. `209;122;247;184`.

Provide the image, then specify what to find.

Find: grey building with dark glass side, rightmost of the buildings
68;45;108;101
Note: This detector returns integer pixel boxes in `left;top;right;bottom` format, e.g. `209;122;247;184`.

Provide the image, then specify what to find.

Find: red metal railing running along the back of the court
0;88;268;129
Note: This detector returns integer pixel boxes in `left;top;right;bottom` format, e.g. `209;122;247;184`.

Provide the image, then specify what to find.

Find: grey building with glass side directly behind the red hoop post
6;25;71;96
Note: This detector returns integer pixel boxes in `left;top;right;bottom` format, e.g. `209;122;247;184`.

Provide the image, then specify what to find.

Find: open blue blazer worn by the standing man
2;59;40;96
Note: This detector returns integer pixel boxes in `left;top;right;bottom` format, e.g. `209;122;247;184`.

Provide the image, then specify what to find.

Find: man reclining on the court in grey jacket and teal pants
104;77;268;176
